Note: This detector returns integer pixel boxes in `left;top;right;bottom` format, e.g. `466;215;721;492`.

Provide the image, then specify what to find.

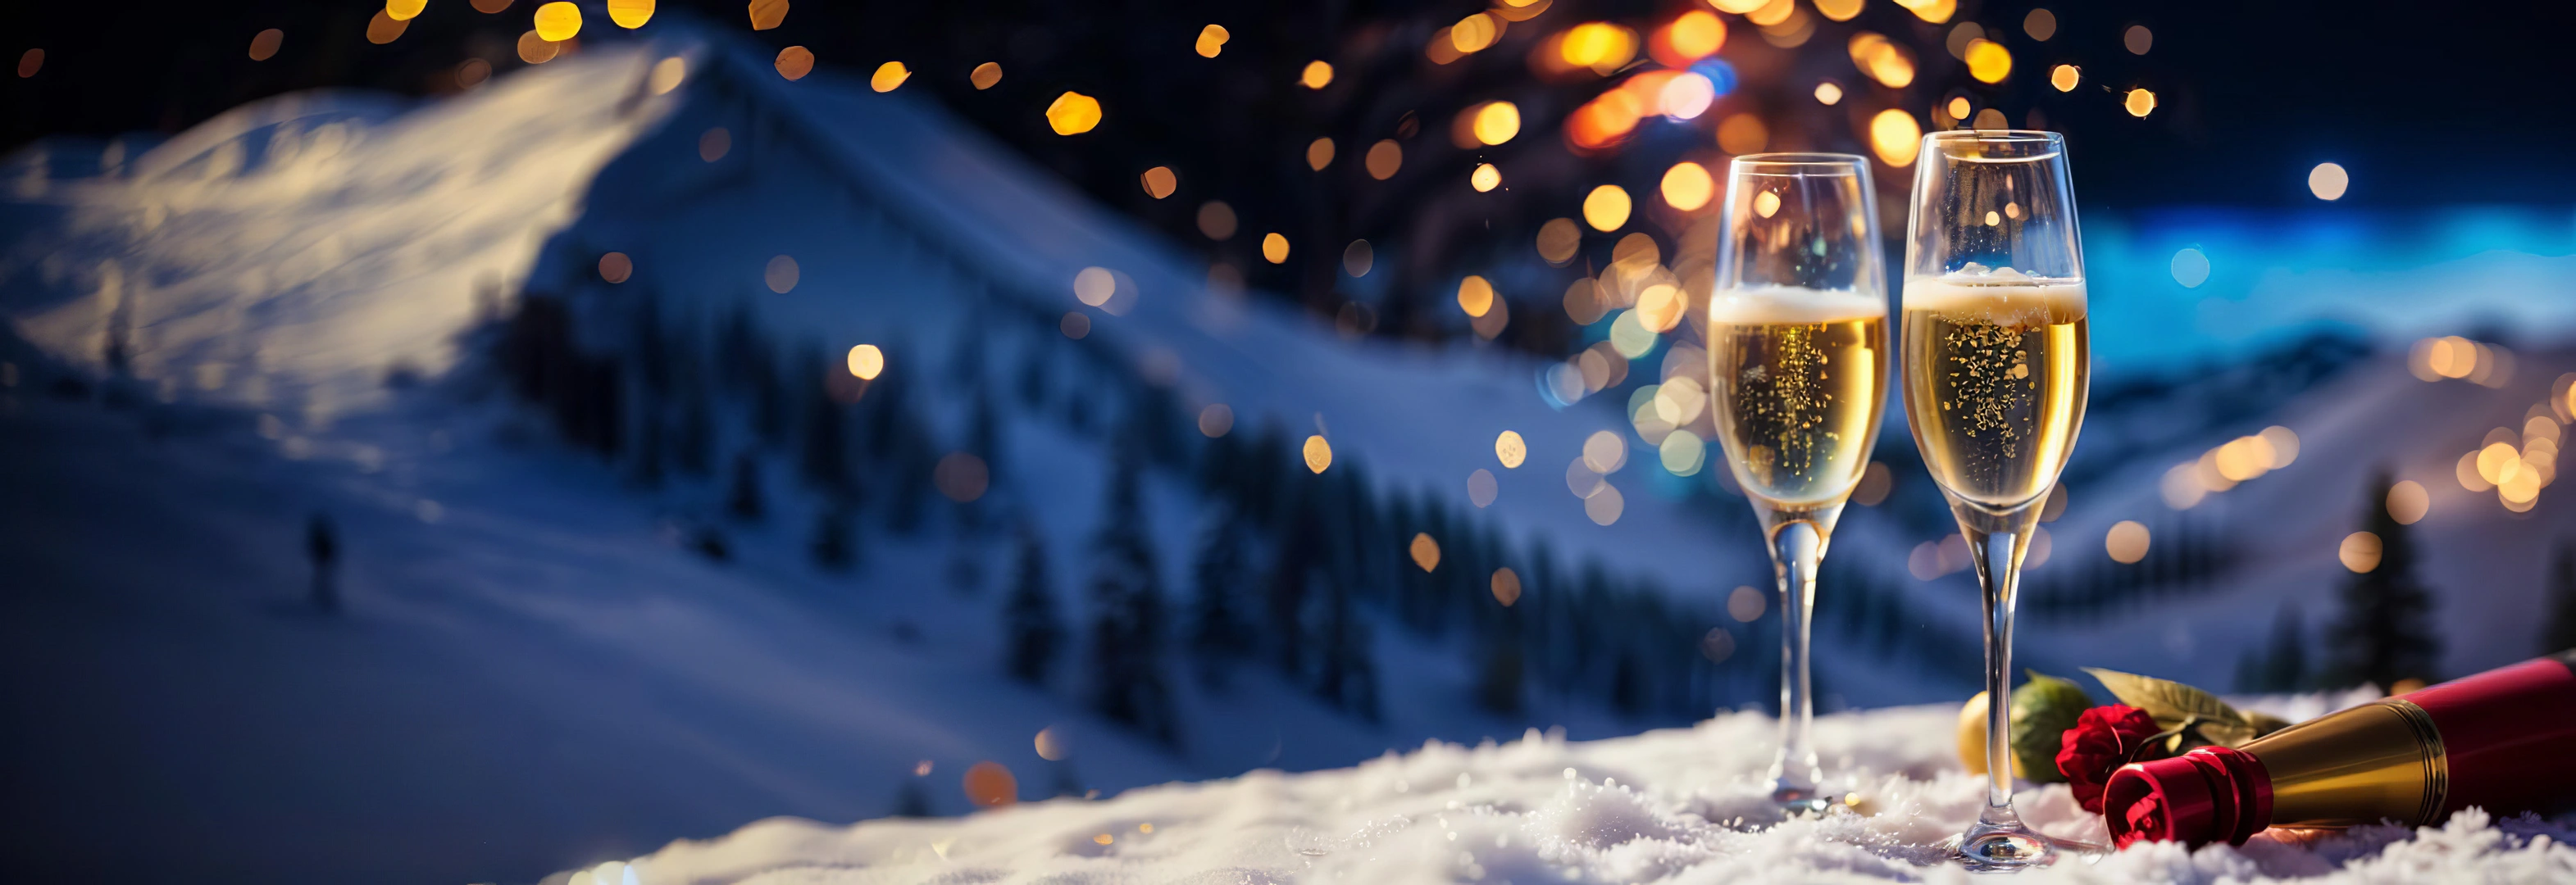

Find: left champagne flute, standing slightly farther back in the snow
1708;154;1888;813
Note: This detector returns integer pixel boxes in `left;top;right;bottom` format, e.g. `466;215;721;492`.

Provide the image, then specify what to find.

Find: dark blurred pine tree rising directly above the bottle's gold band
2334;471;2442;689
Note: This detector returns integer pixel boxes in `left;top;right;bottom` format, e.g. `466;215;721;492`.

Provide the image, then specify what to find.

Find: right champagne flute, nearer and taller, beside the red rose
1904;129;2089;872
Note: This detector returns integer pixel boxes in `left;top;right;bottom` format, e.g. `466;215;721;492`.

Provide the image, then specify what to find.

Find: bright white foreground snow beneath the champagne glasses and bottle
564;697;2576;885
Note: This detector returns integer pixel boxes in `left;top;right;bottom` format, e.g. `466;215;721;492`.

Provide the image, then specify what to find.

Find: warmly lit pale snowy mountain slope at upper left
0;49;672;420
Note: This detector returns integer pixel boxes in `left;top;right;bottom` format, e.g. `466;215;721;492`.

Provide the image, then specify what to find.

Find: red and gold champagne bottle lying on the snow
2102;651;2576;846
